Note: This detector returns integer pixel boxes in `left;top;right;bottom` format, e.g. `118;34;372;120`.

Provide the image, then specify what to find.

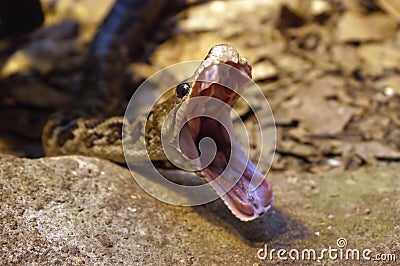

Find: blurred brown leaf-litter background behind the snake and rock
0;0;400;173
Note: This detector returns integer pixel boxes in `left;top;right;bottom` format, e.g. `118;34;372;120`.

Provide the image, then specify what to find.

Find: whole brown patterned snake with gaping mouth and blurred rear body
42;0;274;222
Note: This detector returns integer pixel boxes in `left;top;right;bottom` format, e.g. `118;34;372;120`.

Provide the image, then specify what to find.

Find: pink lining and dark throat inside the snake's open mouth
180;67;273;221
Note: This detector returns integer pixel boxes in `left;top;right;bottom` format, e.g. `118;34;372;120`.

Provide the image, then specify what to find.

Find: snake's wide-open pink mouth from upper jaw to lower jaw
179;45;273;221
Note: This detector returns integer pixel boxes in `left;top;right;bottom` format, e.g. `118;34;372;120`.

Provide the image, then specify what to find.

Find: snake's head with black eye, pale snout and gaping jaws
175;44;273;221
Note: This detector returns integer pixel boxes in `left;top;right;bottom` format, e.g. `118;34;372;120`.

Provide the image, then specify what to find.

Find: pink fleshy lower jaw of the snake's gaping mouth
198;118;273;221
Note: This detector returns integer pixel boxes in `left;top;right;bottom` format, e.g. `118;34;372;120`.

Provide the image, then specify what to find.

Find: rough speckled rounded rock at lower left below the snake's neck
0;156;288;265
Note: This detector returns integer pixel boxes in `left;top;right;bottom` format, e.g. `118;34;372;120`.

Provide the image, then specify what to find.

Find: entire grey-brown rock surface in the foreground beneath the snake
0;156;400;265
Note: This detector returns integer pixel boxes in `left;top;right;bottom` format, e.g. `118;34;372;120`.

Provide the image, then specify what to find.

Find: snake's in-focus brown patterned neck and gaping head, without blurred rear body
42;44;273;221
